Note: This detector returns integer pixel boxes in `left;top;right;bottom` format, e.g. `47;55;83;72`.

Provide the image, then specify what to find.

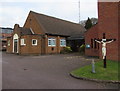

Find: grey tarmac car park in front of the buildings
2;52;118;89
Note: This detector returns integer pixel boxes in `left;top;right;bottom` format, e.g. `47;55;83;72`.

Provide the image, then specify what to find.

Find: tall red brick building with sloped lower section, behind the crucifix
85;2;120;61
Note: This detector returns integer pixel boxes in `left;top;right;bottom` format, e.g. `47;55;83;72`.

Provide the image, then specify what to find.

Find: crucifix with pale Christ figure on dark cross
95;33;116;68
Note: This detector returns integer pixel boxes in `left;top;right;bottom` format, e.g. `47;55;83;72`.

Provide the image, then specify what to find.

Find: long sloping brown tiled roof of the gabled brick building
30;11;86;37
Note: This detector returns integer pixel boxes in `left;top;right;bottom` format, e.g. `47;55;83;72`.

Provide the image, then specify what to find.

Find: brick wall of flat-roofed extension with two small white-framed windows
19;35;41;54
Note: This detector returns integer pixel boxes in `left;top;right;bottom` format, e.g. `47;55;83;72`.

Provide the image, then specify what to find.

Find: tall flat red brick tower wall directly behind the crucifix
98;2;118;60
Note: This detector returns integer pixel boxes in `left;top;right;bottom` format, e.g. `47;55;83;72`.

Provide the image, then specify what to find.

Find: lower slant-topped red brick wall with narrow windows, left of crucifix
85;24;99;56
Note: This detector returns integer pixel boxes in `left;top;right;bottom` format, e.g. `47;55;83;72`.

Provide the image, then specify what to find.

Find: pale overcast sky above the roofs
0;0;98;28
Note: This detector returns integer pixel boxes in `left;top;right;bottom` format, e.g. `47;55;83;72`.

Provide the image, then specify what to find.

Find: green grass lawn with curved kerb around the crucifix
71;60;120;81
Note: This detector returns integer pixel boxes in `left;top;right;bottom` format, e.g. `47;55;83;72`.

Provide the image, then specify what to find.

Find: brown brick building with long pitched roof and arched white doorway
7;11;85;55
